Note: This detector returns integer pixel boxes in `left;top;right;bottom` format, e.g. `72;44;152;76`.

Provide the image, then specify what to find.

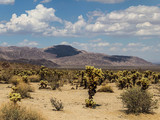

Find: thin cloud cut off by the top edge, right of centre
87;0;125;4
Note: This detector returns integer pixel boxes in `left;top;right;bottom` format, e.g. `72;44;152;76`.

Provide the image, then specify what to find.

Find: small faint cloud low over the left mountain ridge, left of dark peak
18;39;38;47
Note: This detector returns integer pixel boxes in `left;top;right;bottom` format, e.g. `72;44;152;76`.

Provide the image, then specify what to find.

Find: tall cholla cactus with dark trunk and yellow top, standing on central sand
85;66;103;107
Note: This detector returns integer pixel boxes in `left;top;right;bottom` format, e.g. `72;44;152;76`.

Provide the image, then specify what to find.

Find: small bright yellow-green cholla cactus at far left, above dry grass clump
9;93;22;104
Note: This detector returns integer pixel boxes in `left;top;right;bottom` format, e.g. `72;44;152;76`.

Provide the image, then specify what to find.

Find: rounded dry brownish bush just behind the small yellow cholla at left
13;83;34;98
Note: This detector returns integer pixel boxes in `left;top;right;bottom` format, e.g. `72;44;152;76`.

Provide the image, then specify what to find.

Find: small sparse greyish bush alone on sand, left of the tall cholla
50;98;63;111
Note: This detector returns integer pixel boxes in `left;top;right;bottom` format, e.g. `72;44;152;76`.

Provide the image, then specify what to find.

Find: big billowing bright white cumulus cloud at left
0;4;62;34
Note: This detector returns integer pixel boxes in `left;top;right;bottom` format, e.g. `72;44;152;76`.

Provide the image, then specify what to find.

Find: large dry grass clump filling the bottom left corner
0;103;45;120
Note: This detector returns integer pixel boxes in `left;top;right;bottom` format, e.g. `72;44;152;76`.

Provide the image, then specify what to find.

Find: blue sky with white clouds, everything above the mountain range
0;0;160;62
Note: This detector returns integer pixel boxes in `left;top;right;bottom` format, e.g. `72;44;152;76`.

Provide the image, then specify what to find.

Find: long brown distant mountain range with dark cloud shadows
0;45;153;68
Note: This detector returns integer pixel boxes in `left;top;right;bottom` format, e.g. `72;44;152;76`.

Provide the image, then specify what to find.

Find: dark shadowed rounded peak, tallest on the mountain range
44;45;82;58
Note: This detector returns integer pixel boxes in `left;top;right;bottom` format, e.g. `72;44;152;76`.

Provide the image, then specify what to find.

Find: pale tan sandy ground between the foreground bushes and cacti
0;83;160;120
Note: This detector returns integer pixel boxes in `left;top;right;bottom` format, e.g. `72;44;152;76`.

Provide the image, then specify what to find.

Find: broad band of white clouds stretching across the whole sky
0;4;160;38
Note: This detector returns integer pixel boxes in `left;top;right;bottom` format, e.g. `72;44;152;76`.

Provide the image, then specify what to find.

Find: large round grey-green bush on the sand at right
121;87;158;114
